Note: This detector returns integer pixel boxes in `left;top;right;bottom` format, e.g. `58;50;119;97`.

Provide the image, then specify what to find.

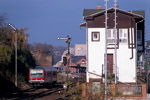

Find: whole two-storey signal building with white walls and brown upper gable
80;8;145;82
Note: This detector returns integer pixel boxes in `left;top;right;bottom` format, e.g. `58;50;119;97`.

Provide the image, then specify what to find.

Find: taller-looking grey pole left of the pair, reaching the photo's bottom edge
104;0;108;100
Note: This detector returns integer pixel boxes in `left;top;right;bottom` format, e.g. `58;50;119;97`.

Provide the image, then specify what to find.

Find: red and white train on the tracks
29;66;57;85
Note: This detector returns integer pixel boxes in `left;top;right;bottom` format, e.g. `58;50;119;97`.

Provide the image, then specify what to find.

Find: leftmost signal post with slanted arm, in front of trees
8;24;18;87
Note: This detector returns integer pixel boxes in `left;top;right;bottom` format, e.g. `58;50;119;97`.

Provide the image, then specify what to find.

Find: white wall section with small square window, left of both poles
87;28;105;81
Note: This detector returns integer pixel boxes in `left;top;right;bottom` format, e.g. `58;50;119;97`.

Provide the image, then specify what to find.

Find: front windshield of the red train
30;70;43;78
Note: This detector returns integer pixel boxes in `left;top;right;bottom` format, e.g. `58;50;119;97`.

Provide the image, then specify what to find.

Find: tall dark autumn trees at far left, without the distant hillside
0;15;36;88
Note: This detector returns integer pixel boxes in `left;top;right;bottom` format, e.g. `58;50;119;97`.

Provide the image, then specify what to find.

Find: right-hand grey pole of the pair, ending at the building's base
114;0;117;84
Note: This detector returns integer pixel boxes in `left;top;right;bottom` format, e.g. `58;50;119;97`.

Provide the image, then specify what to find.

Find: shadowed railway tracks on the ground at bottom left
0;79;83;100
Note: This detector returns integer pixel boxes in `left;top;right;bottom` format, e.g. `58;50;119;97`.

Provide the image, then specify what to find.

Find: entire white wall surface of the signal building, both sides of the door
87;28;136;82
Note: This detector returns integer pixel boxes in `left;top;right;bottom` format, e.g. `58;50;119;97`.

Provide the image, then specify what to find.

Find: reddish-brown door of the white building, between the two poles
107;54;113;74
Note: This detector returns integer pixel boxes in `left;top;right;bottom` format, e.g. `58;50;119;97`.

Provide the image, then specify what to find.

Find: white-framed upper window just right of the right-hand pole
119;29;128;43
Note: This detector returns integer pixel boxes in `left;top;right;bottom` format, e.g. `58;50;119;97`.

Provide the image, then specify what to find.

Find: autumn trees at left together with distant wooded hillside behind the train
0;15;66;88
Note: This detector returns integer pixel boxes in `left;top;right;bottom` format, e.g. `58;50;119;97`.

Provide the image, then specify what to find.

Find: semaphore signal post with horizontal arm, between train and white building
57;35;71;90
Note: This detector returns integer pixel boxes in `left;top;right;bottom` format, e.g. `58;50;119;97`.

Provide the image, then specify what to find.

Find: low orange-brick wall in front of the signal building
82;82;146;100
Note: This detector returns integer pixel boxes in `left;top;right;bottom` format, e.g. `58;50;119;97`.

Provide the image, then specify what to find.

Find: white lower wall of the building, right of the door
108;43;136;82
